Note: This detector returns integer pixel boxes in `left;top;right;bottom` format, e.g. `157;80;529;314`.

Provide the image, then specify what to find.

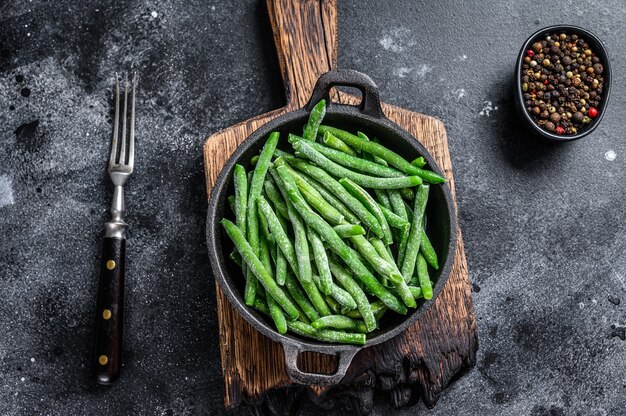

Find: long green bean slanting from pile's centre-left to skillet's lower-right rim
276;166;406;318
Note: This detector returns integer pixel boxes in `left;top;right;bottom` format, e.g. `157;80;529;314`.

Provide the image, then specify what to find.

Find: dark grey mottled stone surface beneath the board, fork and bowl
0;0;626;416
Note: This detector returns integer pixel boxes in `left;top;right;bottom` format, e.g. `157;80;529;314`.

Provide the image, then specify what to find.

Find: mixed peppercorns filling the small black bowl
520;33;604;135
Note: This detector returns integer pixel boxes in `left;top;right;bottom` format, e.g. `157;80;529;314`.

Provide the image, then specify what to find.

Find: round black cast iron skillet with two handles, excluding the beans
207;70;457;385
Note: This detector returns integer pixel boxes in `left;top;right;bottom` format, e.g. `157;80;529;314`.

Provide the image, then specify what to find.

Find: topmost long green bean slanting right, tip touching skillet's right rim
318;125;446;184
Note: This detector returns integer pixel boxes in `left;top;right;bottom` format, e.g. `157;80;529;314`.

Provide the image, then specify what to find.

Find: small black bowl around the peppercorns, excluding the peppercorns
515;25;611;142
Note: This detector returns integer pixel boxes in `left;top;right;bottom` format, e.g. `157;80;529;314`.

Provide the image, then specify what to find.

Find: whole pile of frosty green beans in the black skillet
222;100;445;345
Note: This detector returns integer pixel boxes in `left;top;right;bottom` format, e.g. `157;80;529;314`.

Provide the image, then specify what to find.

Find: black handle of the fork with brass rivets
93;237;126;384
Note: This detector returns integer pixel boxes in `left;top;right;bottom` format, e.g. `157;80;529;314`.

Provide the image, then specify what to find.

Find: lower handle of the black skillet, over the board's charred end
283;343;359;386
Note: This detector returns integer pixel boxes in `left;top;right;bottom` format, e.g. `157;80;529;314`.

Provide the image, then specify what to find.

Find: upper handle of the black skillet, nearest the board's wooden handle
306;69;385;118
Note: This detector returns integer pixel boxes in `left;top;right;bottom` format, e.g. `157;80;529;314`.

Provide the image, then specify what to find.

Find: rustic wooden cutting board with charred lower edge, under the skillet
204;0;478;414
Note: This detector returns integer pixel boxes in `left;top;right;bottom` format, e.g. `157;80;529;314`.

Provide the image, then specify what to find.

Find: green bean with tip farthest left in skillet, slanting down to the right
221;218;298;319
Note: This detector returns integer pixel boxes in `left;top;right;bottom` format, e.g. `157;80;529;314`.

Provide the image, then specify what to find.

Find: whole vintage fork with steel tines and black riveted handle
94;74;137;384
